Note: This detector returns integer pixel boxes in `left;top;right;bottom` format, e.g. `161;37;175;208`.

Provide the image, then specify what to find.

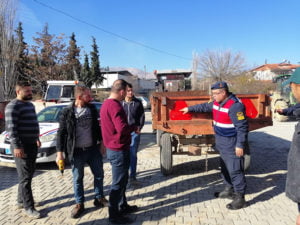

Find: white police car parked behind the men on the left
0;102;102;163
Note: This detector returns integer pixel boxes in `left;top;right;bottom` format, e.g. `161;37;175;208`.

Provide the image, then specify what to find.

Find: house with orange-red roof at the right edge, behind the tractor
251;63;300;80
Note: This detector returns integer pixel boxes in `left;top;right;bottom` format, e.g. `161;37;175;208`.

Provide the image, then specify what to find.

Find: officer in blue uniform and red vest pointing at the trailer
180;81;248;209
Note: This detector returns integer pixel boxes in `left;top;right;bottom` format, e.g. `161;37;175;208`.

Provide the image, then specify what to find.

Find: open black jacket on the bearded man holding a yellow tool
56;102;102;160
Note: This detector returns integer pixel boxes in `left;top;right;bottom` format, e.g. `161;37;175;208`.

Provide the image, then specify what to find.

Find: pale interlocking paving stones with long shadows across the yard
0;113;297;225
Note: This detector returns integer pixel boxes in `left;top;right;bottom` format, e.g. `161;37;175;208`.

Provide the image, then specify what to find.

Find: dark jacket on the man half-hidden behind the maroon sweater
122;96;145;130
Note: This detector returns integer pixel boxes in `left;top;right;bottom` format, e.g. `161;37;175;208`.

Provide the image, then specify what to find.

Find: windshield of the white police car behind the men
37;103;102;123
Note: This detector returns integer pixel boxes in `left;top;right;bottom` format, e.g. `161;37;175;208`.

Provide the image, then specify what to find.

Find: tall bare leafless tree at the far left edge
0;0;20;100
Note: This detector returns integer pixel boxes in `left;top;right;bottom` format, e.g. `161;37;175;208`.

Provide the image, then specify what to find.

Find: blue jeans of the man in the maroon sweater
106;148;130;217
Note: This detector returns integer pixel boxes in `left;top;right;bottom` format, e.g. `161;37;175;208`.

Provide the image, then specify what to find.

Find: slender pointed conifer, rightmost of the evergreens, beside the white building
89;37;104;87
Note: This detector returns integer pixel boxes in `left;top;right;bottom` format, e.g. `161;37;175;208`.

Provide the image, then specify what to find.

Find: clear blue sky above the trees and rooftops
17;0;300;72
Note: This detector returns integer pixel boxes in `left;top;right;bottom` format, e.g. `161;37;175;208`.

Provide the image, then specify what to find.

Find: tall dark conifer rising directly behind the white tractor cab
65;33;81;80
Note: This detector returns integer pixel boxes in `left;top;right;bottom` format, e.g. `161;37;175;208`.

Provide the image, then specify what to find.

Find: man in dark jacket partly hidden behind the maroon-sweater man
122;84;145;185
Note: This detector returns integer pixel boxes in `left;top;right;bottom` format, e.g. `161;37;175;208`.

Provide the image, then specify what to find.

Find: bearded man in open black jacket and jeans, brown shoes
56;86;108;218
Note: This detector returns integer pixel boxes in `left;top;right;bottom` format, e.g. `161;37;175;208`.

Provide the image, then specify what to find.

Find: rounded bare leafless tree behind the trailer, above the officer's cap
194;50;245;81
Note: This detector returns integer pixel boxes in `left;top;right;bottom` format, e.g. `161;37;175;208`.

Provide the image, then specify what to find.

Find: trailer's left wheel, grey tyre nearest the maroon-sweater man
160;133;173;176
